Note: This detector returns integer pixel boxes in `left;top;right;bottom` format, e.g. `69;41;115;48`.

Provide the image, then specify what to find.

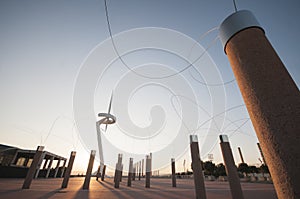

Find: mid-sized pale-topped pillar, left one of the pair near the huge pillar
190;135;206;199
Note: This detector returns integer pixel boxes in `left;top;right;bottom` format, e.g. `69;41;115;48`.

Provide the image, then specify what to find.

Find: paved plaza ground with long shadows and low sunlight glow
0;178;277;199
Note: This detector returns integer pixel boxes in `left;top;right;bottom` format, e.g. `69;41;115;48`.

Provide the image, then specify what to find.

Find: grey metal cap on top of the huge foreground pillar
219;10;263;53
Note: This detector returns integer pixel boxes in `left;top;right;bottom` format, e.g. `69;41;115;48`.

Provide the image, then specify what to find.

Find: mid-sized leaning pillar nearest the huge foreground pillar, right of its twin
220;135;244;199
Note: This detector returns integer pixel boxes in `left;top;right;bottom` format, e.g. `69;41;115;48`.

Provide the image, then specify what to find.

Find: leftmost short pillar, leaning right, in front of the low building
22;146;44;189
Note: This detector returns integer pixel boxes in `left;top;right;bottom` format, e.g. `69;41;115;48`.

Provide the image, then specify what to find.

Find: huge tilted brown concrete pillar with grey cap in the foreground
220;10;300;199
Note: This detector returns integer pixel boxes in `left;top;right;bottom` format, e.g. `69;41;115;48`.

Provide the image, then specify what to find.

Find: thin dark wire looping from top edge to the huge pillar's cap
104;0;219;79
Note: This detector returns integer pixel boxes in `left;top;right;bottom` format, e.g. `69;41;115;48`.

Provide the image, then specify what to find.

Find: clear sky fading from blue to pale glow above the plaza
0;0;300;173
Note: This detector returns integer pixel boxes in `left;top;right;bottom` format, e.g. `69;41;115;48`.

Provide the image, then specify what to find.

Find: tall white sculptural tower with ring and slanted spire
96;93;116;179
